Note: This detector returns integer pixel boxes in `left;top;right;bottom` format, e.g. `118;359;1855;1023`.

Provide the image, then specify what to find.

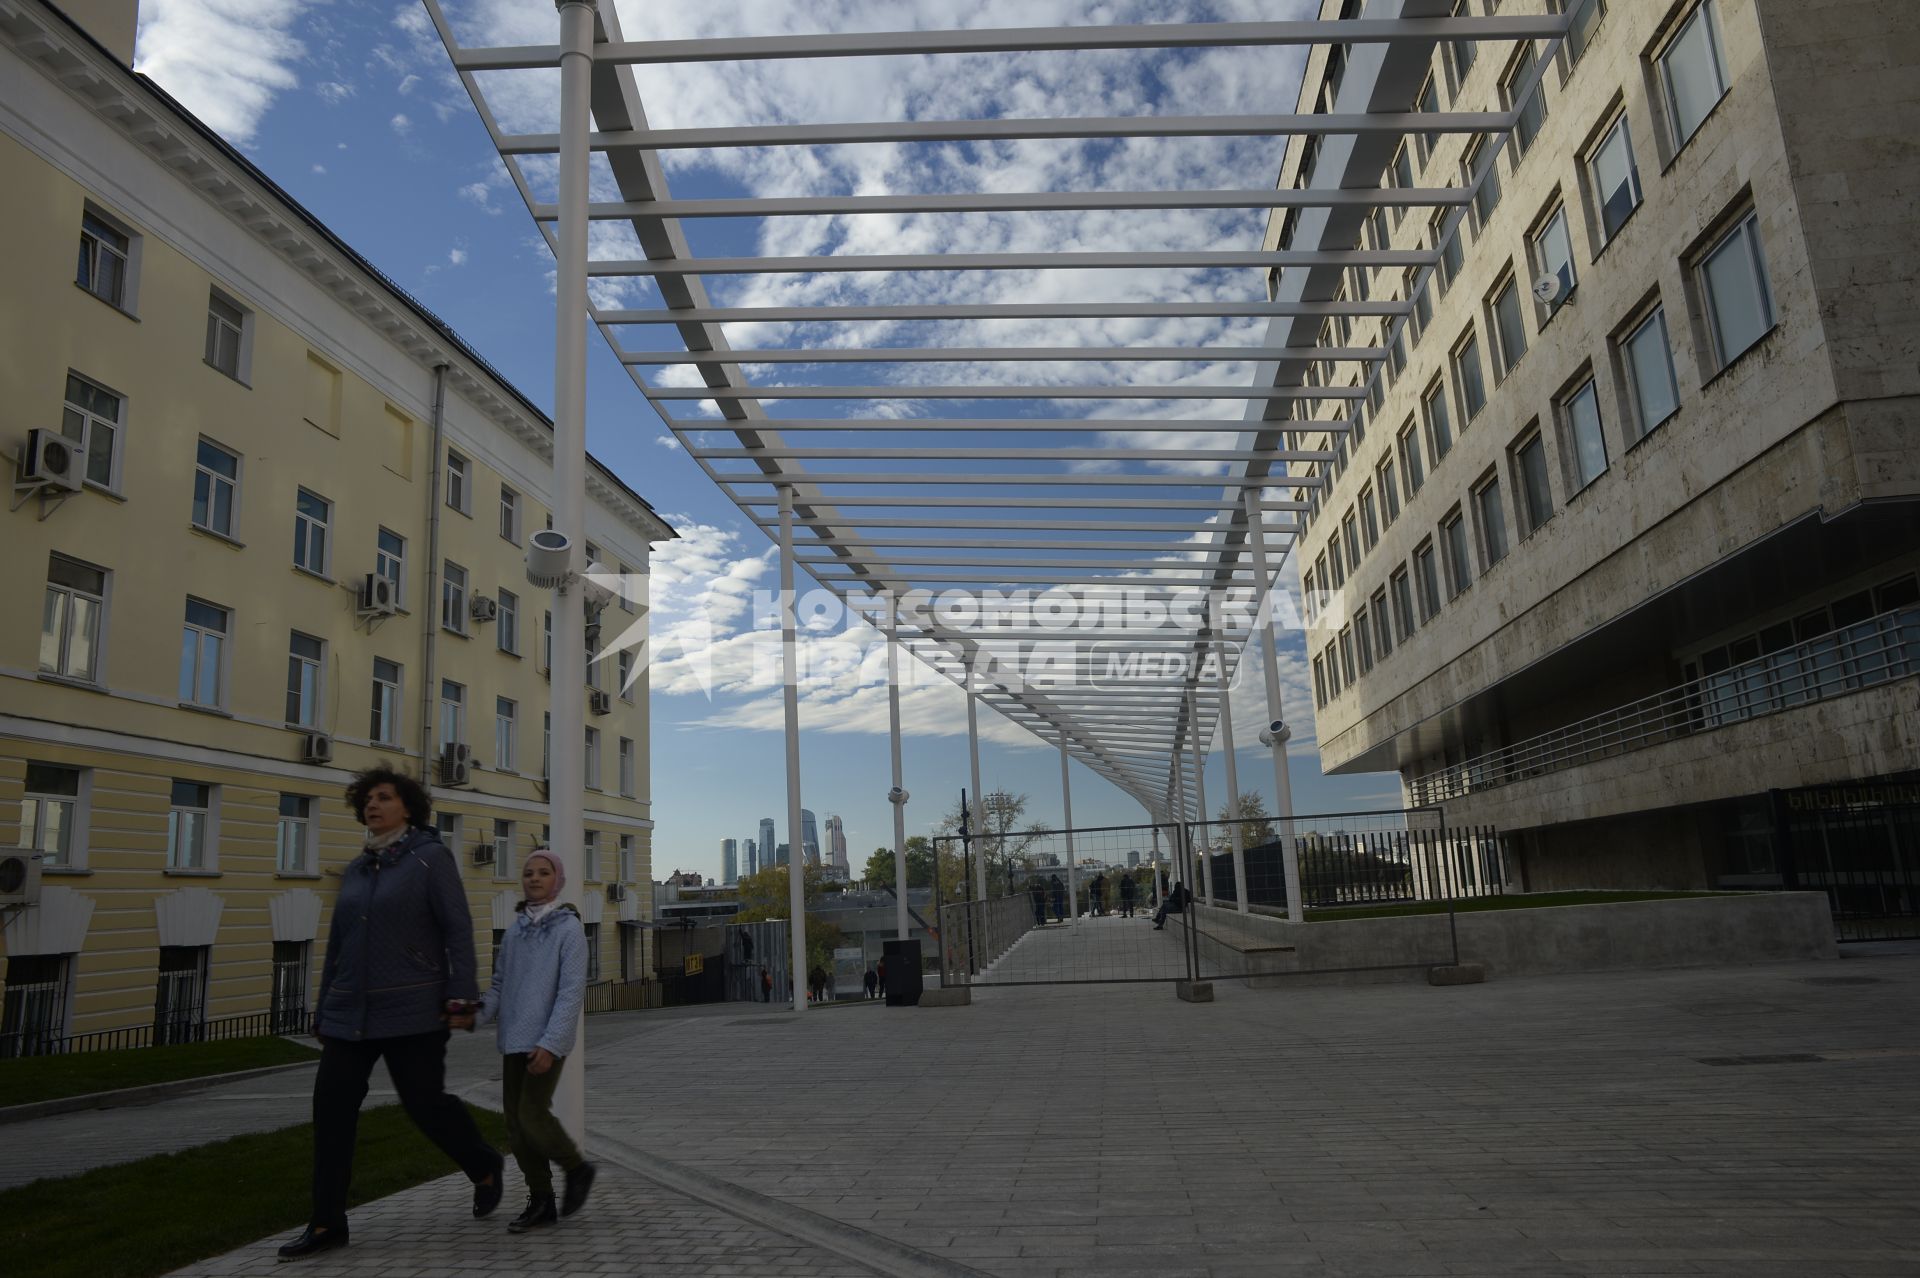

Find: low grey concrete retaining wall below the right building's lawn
1190;892;1839;984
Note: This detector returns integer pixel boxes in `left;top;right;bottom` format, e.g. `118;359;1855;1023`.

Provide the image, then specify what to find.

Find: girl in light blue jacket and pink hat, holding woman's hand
480;848;593;1234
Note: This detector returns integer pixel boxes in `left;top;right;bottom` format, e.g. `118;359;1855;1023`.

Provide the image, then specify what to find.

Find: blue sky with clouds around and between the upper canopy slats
136;0;1400;877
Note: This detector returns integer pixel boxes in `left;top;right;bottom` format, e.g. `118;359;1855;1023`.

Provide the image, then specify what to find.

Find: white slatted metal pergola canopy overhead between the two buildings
426;0;1569;814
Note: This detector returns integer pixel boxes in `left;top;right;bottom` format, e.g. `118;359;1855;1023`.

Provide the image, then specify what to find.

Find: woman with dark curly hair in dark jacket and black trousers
278;766;507;1261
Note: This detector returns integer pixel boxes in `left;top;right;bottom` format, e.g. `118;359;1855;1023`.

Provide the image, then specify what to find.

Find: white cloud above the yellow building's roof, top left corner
134;0;307;144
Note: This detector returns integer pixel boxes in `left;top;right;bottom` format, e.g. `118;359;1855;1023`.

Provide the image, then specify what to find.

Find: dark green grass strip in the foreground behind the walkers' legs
0;1105;507;1278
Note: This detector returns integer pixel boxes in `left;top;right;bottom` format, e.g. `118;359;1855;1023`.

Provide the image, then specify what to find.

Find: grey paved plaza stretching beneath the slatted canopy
10;948;1920;1278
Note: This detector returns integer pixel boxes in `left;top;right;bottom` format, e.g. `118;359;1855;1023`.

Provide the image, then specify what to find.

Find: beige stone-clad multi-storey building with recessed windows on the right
1267;0;1920;890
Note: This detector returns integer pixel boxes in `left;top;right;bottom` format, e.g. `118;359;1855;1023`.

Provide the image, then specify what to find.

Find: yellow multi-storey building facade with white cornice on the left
0;4;674;1053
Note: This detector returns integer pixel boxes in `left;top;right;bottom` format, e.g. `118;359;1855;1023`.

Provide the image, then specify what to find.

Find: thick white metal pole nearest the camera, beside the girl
545;0;593;1142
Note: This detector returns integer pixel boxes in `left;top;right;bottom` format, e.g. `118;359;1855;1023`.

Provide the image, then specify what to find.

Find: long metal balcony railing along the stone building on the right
1407;608;1920;806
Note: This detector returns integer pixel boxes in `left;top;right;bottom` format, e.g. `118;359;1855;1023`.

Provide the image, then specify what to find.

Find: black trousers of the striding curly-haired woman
309;1030;501;1228
